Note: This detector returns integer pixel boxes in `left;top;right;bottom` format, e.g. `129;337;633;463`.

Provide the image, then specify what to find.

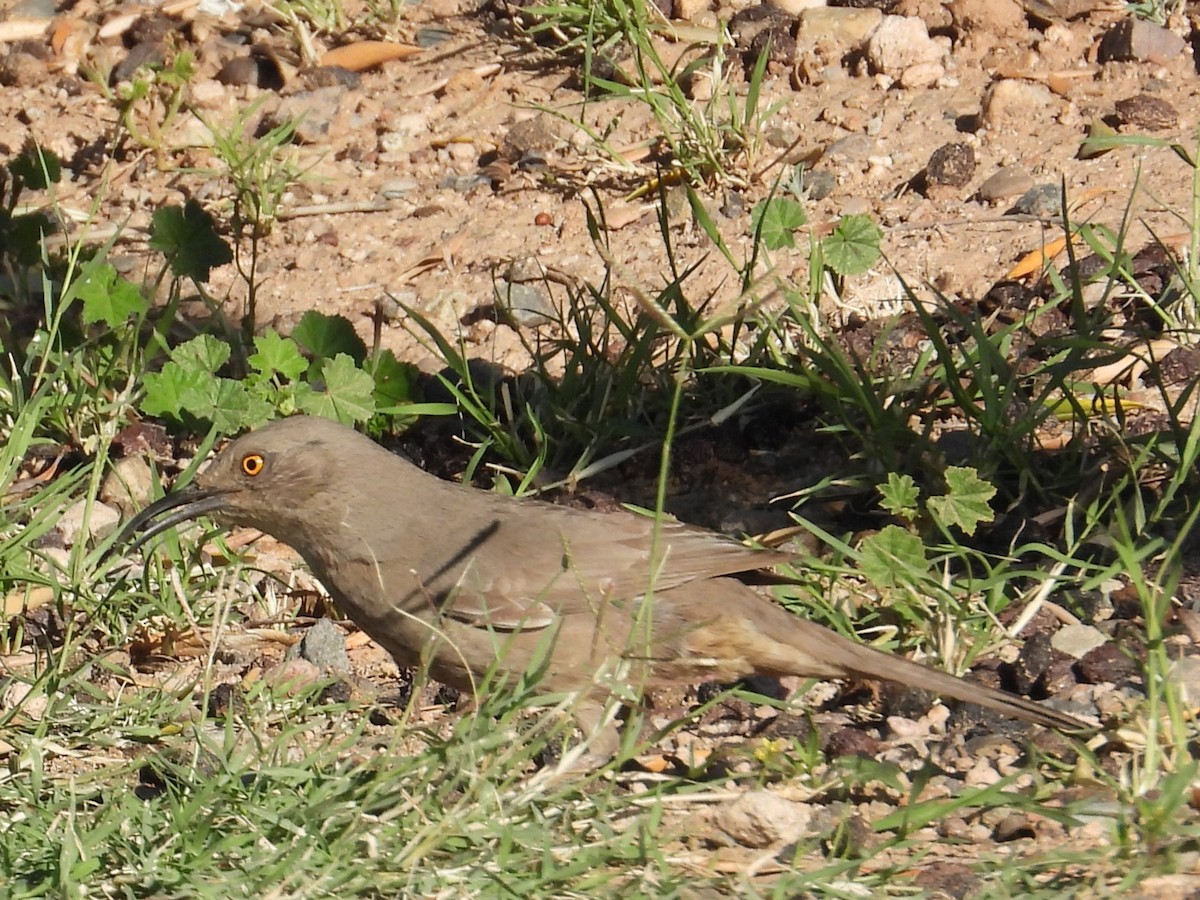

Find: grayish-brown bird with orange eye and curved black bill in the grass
116;415;1088;758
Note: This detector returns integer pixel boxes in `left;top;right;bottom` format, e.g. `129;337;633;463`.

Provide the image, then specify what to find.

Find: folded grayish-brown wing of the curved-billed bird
442;503;790;630
